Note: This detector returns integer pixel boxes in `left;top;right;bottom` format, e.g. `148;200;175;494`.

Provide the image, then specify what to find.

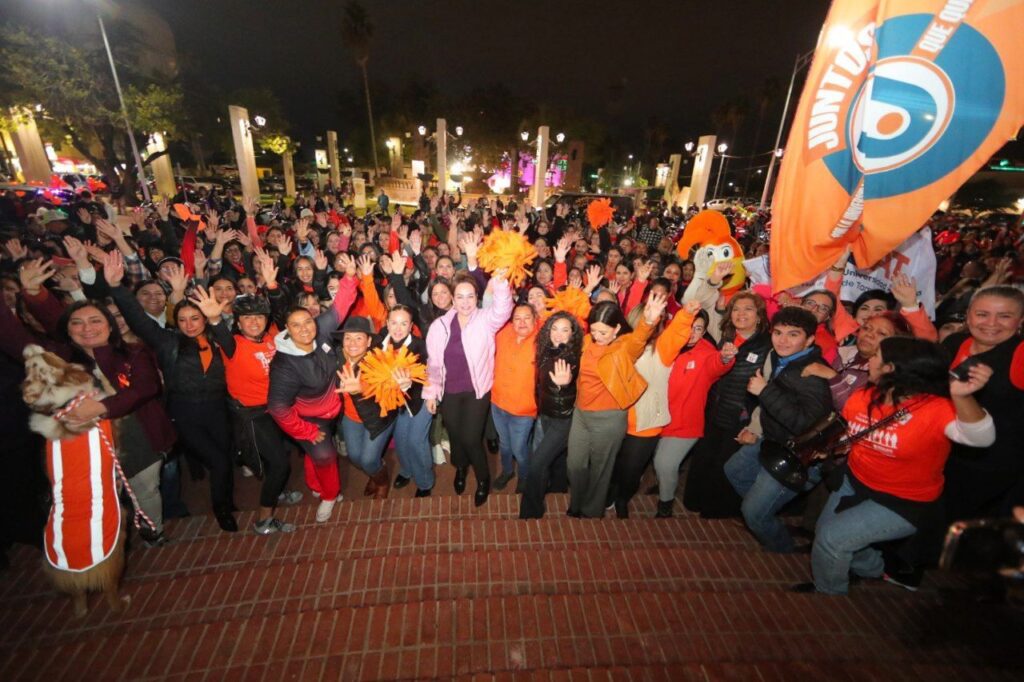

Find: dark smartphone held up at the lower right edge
939;518;1024;572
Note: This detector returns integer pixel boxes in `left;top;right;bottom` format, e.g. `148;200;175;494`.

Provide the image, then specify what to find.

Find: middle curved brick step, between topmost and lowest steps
0;548;823;649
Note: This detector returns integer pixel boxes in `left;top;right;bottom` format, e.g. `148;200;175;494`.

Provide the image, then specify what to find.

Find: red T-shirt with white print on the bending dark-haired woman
843;388;956;502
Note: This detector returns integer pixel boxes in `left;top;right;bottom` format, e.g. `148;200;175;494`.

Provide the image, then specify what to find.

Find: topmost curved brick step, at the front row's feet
0;509;761;600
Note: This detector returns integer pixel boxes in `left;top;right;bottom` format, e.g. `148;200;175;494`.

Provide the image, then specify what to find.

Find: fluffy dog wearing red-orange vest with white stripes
22;345;129;617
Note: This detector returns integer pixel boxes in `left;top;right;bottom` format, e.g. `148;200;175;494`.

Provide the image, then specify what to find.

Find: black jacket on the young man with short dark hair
757;344;833;442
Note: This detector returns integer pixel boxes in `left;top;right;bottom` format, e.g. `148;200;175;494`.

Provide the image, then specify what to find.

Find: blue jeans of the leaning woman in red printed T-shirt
811;474;918;594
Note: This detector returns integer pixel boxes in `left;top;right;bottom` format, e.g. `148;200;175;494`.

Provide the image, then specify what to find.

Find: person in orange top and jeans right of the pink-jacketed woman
490;304;540;491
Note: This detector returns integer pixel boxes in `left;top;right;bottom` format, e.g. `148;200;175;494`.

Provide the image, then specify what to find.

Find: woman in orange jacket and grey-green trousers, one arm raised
567;294;668;518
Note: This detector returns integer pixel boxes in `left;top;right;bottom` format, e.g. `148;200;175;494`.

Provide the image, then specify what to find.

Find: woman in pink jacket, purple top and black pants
423;270;512;507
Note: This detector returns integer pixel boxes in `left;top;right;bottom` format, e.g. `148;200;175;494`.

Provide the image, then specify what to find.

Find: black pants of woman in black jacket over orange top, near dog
168;400;234;513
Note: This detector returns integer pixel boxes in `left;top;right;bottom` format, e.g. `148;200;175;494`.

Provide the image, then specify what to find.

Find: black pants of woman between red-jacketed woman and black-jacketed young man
683;425;742;518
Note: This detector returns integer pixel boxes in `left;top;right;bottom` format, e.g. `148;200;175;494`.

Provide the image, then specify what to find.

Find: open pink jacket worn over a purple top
423;280;512;400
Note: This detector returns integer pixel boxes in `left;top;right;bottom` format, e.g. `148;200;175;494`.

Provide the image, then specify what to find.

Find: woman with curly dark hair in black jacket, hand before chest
519;312;585;518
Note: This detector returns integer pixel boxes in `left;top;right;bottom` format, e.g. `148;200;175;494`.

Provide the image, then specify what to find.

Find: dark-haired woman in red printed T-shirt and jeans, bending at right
796;337;995;594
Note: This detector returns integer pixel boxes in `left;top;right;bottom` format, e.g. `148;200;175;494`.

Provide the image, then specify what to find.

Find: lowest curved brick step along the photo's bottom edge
6;592;1019;681
